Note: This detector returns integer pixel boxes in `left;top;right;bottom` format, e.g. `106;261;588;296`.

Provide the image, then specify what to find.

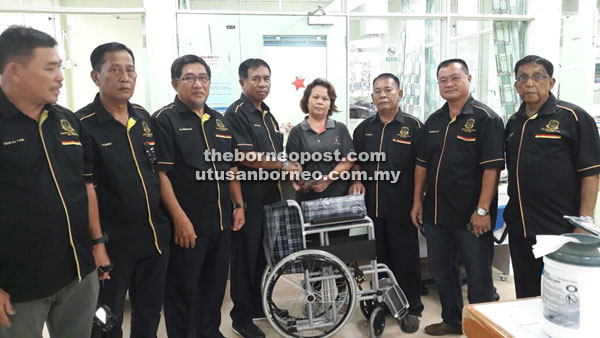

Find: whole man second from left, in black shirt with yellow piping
76;42;170;338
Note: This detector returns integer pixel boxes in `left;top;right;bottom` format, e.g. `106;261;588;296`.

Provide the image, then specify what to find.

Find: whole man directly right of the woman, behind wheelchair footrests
350;73;423;332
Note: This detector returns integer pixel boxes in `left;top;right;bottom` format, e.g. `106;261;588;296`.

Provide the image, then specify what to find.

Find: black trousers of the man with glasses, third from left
164;230;231;338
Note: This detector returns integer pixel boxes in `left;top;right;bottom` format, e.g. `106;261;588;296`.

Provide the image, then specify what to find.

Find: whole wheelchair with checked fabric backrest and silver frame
262;196;409;337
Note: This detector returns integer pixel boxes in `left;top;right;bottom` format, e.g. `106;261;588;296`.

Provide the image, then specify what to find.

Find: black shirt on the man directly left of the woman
225;94;283;218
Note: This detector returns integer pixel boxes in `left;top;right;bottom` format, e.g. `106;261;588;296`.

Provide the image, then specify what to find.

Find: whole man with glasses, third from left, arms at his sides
153;55;244;338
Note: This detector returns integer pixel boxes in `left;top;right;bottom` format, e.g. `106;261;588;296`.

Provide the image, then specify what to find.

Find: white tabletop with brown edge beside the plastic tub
463;297;549;338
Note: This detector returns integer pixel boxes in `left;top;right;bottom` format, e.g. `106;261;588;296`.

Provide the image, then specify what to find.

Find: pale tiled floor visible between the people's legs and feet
117;271;515;338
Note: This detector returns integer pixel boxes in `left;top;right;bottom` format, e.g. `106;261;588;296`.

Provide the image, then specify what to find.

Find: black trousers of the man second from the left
92;248;169;338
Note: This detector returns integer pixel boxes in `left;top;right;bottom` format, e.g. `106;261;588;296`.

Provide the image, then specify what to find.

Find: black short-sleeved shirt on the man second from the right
417;96;504;227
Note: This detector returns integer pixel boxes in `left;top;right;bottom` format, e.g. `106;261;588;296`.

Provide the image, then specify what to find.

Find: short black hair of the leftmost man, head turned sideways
0;25;57;74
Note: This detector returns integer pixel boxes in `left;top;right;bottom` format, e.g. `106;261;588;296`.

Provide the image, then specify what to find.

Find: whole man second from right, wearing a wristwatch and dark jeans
411;59;504;336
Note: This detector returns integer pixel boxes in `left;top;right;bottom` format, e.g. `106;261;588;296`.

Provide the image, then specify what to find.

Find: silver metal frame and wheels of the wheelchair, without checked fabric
262;200;408;337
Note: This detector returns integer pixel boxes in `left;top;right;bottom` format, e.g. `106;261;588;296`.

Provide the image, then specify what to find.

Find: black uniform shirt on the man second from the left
76;95;170;259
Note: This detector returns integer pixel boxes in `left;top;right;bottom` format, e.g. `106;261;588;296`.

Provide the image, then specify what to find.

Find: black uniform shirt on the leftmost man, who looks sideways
0;90;95;302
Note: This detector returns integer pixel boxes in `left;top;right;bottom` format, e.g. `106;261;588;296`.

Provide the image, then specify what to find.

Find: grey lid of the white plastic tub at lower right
547;234;600;267
